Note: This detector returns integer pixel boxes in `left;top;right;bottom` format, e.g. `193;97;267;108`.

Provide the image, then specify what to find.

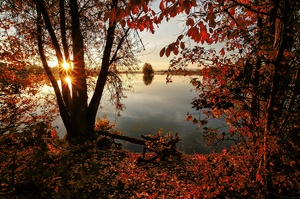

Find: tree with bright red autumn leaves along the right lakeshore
160;0;300;197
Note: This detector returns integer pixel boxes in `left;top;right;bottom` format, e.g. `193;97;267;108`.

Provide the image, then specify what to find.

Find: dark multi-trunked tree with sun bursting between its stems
1;0;154;140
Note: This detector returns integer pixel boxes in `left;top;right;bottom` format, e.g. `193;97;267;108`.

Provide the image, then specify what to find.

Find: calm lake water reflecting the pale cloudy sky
56;74;228;154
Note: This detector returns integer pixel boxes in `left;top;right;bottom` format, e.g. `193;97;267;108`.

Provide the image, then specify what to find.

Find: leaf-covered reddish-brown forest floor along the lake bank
0;136;300;199
